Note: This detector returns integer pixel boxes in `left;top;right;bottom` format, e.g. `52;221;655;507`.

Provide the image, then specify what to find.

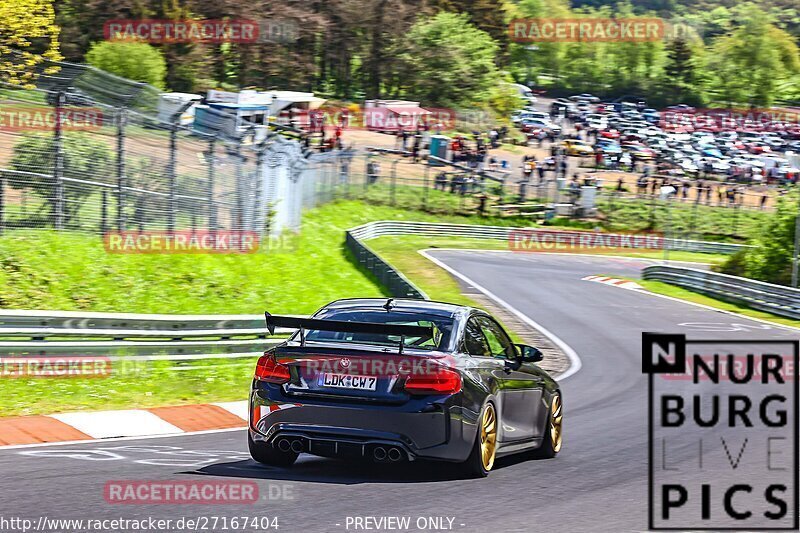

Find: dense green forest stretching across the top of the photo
0;0;800;109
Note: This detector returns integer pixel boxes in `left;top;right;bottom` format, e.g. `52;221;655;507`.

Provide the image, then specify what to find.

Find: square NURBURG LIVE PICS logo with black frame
642;333;800;531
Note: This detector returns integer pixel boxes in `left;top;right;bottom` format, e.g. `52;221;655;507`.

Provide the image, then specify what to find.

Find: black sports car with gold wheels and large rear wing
248;299;563;476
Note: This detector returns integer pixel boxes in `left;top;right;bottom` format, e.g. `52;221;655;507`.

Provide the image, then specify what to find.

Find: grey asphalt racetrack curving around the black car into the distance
0;250;798;533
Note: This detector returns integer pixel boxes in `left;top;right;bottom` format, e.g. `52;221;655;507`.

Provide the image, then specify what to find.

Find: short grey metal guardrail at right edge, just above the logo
643;265;800;319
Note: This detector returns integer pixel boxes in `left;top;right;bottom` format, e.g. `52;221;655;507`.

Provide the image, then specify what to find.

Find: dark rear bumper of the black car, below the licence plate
250;386;475;461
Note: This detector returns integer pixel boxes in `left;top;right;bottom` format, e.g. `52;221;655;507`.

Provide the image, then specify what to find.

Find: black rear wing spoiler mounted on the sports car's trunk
264;311;441;353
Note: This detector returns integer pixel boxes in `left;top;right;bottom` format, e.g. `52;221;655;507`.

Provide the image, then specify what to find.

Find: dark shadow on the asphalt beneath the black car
188;454;552;485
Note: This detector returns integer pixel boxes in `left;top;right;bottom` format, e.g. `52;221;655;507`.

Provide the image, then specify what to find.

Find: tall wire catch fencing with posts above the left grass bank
0;58;353;236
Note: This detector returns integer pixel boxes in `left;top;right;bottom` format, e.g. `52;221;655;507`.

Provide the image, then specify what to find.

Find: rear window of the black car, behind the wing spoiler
292;309;453;350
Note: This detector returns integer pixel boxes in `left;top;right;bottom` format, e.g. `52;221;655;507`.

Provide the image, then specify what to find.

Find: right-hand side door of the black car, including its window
476;315;542;442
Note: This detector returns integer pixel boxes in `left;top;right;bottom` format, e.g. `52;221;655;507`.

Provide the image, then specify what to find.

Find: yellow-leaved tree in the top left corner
0;0;61;86
